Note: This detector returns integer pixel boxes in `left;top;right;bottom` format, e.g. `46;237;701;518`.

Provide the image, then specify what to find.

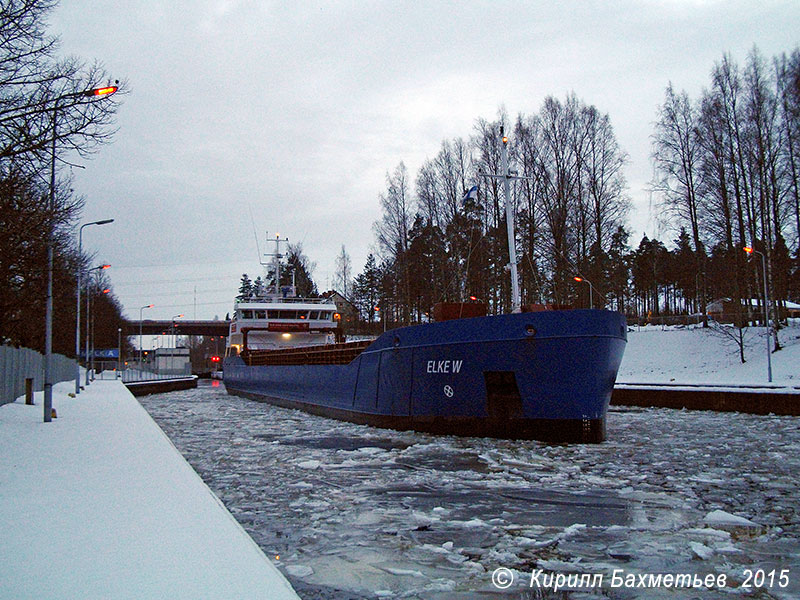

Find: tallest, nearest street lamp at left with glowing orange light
44;86;117;423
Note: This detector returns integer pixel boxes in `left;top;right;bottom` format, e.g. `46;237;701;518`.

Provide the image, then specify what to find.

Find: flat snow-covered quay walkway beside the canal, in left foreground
0;381;297;600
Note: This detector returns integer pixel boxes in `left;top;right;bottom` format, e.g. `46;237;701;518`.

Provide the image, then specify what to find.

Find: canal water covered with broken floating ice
139;381;800;600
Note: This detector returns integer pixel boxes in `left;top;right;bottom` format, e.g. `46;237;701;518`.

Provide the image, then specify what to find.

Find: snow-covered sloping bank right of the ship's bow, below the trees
617;319;800;386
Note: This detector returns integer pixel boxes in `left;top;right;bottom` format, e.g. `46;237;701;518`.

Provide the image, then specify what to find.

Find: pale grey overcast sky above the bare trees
50;0;800;319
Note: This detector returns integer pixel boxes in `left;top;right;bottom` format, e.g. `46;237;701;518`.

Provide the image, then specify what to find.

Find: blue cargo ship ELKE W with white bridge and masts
224;132;627;442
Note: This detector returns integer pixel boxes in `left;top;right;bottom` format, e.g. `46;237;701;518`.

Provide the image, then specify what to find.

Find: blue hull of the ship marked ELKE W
224;310;627;442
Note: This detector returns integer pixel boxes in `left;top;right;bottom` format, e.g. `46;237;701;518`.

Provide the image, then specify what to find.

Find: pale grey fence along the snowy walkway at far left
0;346;75;404
